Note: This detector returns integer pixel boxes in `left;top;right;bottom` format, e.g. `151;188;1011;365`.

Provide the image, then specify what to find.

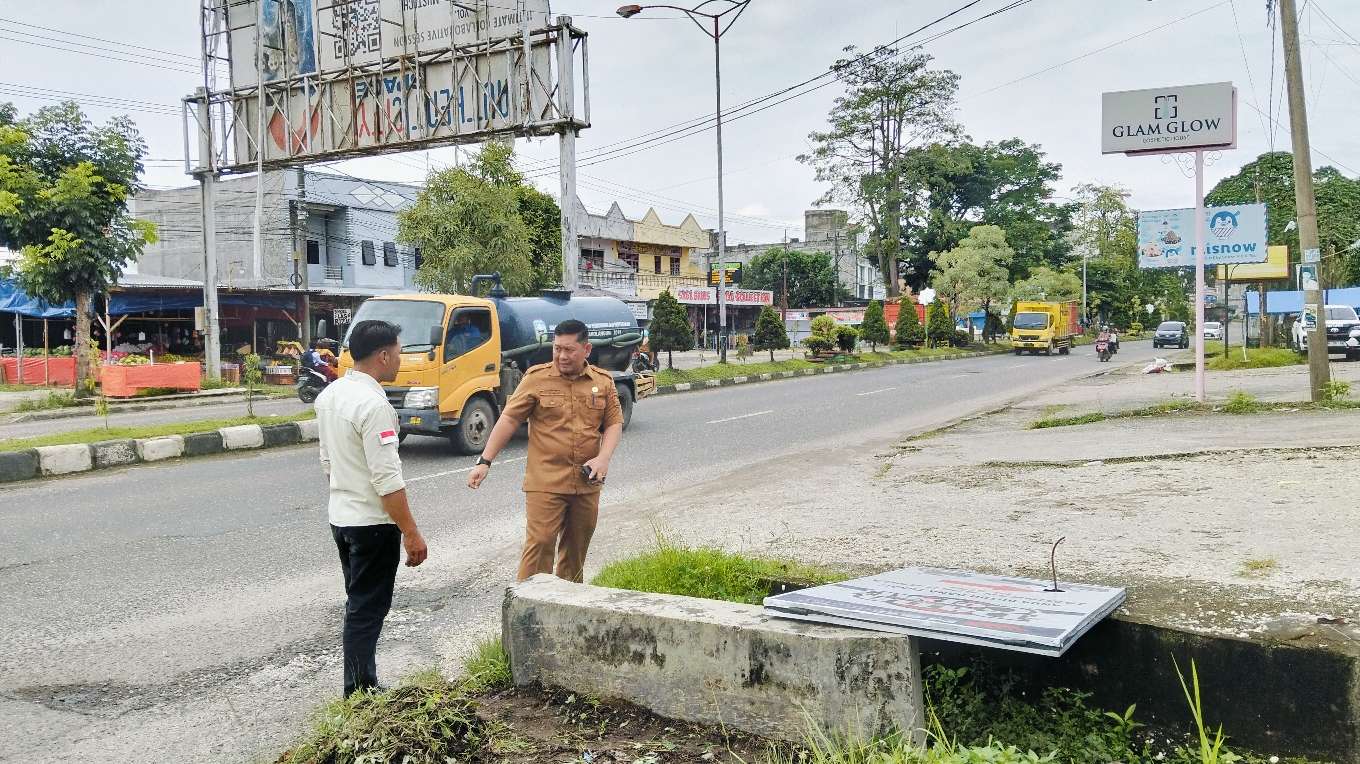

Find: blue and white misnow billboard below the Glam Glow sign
1138;204;1268;268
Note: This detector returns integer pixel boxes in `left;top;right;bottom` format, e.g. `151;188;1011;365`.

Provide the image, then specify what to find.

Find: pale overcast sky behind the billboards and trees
0;0;1360;242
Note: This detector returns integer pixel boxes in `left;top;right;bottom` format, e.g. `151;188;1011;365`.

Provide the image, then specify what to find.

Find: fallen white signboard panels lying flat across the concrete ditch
764;568;1126;657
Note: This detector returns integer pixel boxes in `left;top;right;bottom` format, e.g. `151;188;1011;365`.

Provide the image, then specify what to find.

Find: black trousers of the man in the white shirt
330;523;401;697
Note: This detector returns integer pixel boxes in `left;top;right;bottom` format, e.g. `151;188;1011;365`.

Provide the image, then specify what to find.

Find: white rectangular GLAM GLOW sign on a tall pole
1100;83;1238;154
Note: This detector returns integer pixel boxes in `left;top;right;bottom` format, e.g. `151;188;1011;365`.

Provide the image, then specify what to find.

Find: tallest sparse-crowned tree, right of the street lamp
800;46;960;296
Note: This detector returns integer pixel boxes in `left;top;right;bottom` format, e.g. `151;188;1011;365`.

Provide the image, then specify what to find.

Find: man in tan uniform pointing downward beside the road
468;319;623;583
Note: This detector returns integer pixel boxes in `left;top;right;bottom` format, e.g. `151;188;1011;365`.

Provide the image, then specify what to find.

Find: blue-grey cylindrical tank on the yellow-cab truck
491;291;642;371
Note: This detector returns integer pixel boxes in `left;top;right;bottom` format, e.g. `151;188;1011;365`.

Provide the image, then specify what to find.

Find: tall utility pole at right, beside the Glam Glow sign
1278;0;1331;401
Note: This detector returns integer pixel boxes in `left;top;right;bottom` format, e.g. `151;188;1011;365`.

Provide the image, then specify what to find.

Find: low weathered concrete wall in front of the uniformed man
502;575;925;741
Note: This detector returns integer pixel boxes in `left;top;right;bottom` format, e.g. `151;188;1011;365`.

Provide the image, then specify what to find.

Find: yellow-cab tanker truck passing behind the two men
331;277;644;454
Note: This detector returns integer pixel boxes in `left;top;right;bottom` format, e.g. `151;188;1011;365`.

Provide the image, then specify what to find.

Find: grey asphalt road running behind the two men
0;343;1152;761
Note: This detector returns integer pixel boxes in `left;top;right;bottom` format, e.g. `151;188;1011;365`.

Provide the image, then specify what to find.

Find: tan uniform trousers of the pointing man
518;491;600;583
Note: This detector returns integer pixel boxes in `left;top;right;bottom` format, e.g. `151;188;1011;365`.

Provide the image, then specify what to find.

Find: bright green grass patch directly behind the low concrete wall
590;538;846;605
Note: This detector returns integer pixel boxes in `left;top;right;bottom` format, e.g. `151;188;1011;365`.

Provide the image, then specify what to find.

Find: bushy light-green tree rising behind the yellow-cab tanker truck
397;141;546;294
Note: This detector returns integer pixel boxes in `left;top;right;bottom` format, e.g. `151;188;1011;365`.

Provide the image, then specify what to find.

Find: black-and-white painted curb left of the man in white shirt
0;419;317;483
